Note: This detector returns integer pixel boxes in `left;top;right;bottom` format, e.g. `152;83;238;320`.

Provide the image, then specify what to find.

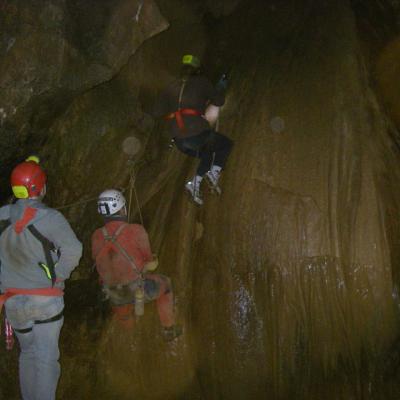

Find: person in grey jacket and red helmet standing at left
0;160;82;400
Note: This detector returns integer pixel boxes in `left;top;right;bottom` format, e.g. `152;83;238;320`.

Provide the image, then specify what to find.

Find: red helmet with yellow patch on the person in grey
11;161;46;199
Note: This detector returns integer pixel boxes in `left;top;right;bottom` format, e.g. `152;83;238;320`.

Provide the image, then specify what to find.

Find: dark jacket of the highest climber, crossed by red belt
154;75;225;138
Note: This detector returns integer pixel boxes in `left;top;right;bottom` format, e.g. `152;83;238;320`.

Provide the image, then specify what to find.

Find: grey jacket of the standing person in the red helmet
0;199;82;291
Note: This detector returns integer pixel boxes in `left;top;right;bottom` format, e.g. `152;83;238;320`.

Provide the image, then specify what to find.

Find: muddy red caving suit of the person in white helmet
92;218;175;328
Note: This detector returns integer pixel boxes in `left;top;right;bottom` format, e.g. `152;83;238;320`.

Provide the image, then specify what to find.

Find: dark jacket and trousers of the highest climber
154;75;232;176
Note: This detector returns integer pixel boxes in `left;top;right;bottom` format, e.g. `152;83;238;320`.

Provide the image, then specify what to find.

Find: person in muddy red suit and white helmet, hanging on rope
92;189;182;341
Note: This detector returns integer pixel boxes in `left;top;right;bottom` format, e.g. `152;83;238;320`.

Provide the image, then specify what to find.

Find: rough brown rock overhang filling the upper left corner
0;0;168;189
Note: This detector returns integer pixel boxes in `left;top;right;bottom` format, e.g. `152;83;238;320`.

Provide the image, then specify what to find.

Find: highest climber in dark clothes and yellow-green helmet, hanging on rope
154;55;233;205
